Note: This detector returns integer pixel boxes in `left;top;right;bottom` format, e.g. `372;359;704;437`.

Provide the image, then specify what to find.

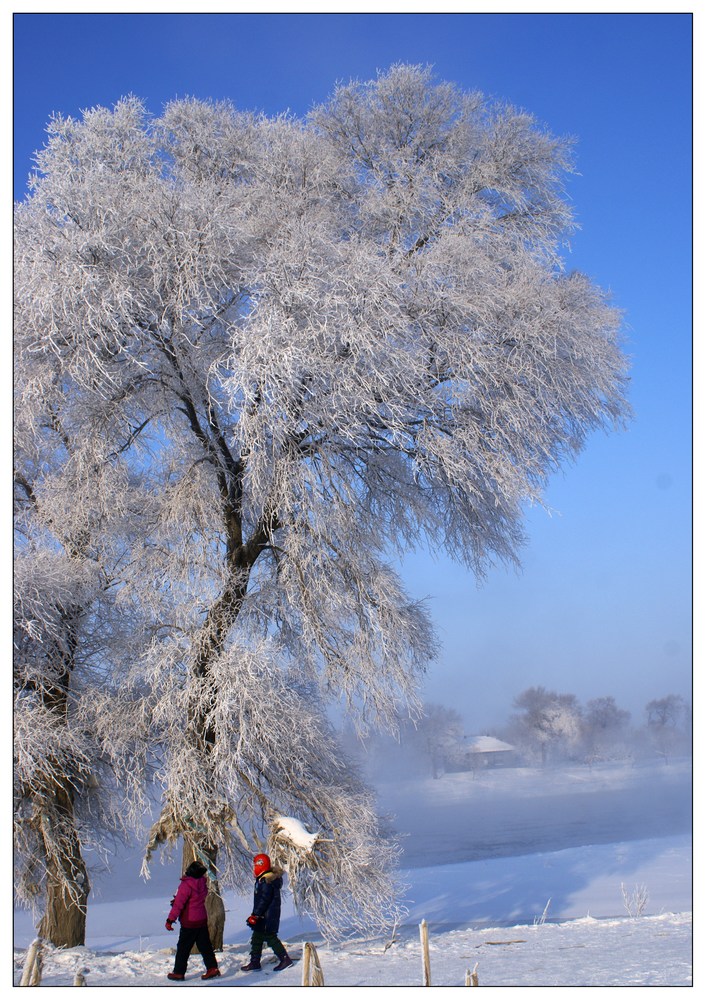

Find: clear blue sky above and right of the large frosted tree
14;7;692;732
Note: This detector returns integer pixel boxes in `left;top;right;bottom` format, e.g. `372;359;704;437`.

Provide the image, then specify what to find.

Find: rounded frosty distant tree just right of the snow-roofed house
511;687;582;766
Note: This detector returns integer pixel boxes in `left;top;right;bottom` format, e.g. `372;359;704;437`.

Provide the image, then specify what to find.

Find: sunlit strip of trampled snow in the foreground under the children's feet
14;913;691;988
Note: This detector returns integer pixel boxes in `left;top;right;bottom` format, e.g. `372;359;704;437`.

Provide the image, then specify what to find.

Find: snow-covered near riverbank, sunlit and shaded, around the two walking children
14;835;691;989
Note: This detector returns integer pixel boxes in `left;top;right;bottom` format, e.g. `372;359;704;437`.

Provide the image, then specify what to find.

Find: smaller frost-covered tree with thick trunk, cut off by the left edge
14;325;153;947
